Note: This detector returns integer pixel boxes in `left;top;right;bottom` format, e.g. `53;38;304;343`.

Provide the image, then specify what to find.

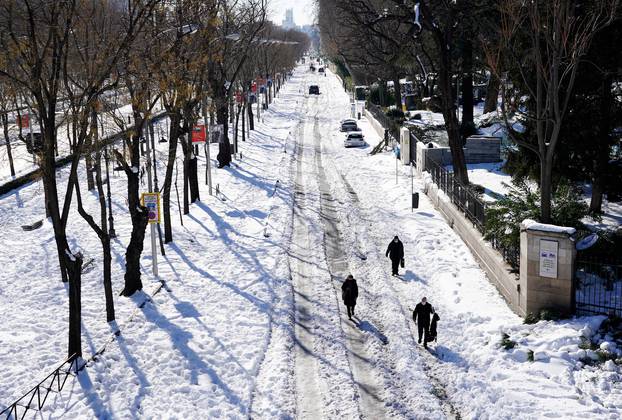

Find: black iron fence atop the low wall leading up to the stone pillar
424;155;520;270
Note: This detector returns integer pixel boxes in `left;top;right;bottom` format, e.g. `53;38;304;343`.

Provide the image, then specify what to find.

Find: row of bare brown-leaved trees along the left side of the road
0;0;308;357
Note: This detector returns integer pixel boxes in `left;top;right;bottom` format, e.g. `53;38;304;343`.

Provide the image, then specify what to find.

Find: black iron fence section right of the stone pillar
574;256;622;317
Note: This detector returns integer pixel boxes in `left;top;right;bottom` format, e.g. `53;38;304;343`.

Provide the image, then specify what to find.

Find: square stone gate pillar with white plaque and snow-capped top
520;220;576;314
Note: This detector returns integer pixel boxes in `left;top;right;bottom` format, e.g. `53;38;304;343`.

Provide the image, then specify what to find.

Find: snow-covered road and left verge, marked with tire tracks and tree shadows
0;66;622;419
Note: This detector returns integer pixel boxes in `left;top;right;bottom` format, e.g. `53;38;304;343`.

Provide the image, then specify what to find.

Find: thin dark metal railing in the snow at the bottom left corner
0;355;83;420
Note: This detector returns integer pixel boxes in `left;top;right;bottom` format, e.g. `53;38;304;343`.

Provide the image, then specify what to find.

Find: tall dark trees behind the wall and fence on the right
317;0;620;222
